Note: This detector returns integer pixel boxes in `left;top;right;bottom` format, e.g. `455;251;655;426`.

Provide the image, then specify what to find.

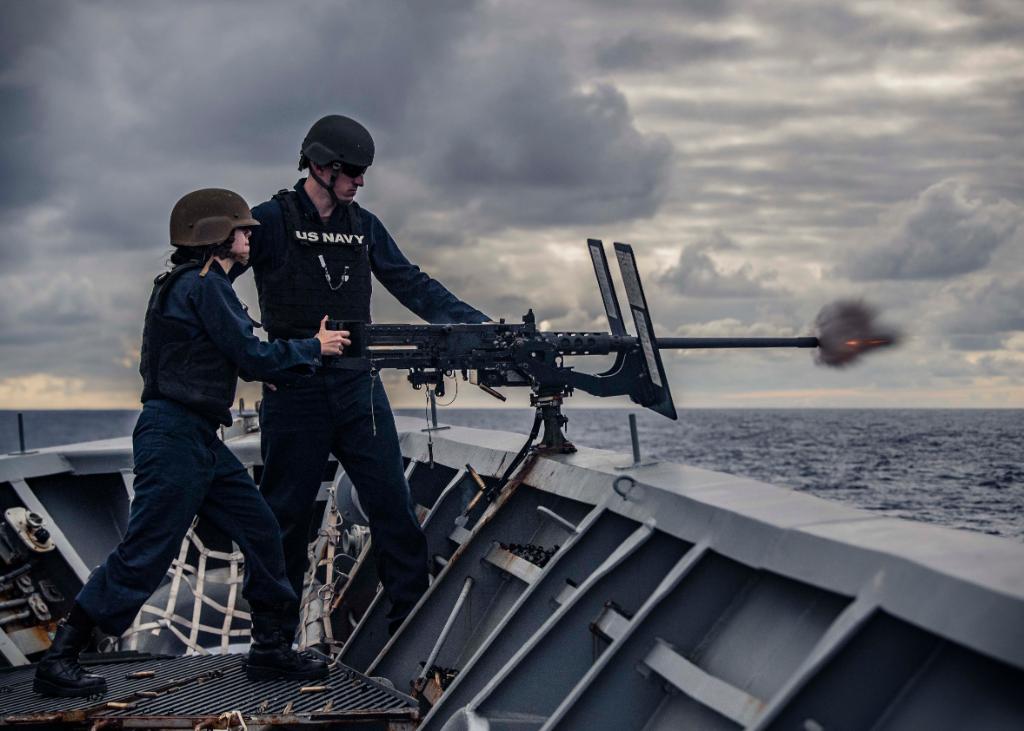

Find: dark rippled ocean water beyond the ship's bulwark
0;409;1024;542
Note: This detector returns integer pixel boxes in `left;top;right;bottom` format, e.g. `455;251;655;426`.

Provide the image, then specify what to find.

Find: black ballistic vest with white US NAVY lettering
259;190;371;339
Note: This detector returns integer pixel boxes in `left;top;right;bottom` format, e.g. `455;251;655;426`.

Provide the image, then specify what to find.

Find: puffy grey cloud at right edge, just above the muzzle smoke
839;180;1024;280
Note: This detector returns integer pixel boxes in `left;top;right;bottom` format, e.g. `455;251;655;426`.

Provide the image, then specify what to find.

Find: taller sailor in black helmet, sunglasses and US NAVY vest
250;115;489;633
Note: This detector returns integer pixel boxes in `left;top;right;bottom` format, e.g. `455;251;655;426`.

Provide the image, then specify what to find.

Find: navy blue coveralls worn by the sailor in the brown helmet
76;263;321;635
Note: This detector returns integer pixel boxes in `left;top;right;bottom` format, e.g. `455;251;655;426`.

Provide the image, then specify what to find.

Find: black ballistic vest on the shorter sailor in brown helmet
138;262;239;425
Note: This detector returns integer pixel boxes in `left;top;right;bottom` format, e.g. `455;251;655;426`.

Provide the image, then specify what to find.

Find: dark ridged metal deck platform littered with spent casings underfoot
0;654;419;730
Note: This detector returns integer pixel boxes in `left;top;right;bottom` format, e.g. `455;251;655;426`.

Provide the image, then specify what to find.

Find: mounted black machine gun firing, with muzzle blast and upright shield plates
328;239;894;452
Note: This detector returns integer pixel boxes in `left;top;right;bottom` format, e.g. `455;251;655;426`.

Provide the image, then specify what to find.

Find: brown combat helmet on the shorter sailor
171;187;259;246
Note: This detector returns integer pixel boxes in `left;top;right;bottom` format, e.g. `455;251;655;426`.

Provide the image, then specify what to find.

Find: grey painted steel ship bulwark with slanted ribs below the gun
0;419;1024;730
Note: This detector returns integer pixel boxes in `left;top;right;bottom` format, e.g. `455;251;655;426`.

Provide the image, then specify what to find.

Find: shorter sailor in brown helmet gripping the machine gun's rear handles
34;188;349;696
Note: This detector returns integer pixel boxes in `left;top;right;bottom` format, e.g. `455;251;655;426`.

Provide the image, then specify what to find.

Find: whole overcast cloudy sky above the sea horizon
0;0;1024;409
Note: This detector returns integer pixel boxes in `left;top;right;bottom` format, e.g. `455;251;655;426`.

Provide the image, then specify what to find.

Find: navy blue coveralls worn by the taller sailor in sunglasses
250;179;489;630
